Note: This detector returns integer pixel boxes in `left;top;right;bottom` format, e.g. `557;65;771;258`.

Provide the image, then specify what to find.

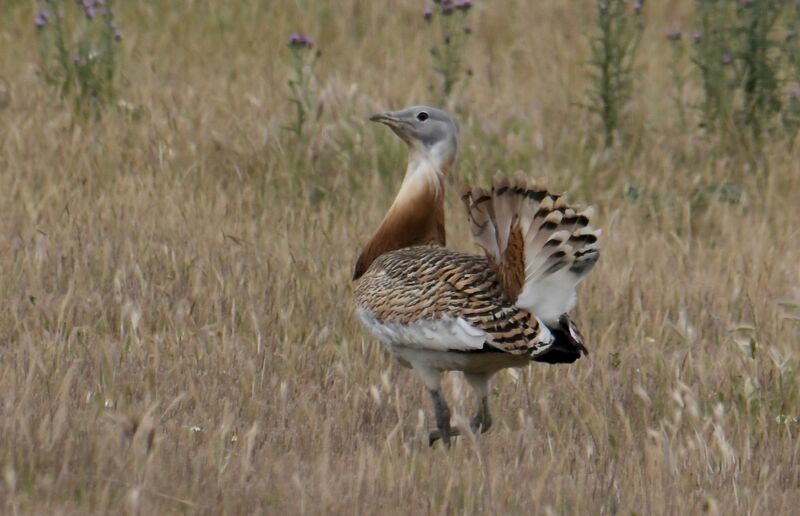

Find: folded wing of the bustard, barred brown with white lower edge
356;246;550;354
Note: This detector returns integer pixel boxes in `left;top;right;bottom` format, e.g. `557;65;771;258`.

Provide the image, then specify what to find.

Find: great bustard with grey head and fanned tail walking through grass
353;106;600;448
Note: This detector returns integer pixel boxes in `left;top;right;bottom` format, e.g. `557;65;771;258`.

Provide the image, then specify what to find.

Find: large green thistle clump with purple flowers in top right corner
676;0;800;145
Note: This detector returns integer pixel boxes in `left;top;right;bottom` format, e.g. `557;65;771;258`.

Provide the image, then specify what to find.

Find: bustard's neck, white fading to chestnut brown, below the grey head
353;152;446;279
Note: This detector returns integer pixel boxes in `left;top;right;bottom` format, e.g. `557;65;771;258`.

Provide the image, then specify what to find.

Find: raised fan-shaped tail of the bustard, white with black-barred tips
462;172;600;327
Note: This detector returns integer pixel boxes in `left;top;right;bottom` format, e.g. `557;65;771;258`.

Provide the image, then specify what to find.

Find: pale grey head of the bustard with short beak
370;106;458;172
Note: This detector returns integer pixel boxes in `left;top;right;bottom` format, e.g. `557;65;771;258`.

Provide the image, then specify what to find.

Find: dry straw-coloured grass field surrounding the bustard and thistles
0;0;800;515
